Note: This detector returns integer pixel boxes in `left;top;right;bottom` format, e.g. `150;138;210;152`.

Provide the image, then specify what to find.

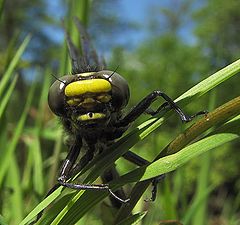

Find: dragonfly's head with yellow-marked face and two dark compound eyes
48;70;129;126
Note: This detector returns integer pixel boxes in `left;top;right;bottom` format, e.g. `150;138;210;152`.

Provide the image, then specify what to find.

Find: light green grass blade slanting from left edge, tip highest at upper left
0;35;31;97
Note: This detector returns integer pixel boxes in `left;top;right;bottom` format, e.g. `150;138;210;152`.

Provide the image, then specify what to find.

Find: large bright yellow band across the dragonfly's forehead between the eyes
65;79;112;97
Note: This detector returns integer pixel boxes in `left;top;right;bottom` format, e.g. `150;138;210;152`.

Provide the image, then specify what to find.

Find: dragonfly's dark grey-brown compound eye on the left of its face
48;75;75;116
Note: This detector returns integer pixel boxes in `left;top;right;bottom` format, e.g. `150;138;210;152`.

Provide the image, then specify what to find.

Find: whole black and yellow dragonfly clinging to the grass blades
34;18;205;221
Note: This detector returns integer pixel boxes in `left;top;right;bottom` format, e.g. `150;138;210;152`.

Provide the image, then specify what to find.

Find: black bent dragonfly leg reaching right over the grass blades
116;90;206;127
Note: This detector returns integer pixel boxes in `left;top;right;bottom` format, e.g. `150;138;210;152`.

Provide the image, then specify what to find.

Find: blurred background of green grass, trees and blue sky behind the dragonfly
0;0;240;225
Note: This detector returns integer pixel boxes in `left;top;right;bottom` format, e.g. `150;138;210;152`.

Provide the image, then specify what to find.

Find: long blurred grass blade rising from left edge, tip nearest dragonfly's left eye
0;82;34;186
